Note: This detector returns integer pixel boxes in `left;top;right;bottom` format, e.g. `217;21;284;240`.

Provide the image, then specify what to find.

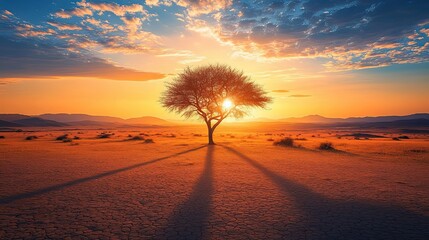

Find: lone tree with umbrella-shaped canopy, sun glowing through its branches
161;65;271;145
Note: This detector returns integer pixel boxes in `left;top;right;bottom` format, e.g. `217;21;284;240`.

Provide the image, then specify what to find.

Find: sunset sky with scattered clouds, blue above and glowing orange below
0;0;429;119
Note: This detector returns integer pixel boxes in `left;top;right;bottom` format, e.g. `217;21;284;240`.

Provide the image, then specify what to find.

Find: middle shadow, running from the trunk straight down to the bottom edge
160;145;215;239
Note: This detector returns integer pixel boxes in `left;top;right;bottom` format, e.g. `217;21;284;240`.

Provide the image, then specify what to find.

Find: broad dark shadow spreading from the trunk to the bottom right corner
224;146;429;239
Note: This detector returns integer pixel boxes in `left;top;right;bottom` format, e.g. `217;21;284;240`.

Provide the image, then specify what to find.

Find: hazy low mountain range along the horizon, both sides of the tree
0;113;429;128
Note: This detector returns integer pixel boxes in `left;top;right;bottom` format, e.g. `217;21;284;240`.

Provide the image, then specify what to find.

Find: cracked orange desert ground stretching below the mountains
0;124;429;239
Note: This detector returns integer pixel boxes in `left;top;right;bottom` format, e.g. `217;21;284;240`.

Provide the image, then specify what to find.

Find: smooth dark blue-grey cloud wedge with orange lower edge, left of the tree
0;37;165;81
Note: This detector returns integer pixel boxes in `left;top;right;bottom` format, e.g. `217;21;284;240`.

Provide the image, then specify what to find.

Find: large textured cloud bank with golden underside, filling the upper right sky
183;0;429;69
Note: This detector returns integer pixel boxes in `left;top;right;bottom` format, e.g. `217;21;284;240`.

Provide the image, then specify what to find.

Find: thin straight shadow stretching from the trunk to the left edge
0;146;206;204
